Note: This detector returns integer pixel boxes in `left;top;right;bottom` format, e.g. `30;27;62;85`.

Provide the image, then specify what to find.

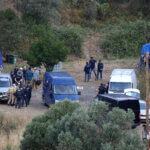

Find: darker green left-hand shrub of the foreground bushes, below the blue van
21;101;80;150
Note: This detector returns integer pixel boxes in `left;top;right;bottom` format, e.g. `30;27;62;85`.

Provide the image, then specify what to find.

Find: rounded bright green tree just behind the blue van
27;28;69;71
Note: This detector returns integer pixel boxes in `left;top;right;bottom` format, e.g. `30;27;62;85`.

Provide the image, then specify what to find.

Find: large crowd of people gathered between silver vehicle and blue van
8;66;40;108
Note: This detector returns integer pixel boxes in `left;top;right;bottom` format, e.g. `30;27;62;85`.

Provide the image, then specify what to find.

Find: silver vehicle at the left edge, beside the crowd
0;73;12;101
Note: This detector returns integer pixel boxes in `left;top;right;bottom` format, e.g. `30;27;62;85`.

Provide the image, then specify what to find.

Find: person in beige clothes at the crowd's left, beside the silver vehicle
8;84;16;105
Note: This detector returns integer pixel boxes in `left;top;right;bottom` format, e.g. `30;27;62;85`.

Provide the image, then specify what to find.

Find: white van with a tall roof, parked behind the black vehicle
108;69;137;94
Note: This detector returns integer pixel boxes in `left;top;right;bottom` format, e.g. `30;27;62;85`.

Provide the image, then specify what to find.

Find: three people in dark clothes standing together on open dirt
84;57;104;82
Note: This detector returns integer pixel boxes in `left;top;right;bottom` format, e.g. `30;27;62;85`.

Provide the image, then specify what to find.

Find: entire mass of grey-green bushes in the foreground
21;101;143;150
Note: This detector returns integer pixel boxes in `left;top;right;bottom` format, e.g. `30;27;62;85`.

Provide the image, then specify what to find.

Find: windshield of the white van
109;82;131;93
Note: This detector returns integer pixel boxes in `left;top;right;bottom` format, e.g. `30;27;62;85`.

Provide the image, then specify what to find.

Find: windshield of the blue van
54;85;77;95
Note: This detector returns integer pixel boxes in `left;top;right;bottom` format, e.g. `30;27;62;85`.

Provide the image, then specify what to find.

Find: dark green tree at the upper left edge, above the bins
0;8;26;54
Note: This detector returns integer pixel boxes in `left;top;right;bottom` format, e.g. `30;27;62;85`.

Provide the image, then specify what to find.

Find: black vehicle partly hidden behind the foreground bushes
96;94;140;126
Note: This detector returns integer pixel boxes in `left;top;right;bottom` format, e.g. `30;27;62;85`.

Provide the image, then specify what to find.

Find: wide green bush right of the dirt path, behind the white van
102;21;150;58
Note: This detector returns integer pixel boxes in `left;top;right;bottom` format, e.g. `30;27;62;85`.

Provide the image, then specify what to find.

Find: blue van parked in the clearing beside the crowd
42;72;80;106
